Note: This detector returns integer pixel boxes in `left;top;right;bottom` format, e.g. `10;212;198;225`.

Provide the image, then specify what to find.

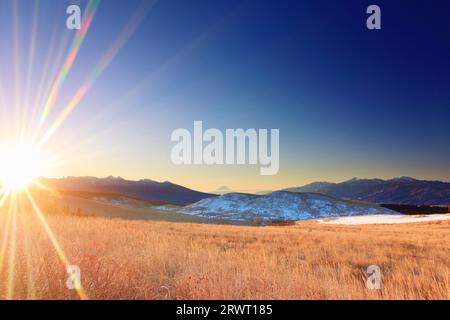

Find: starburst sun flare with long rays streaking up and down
0;0;151;299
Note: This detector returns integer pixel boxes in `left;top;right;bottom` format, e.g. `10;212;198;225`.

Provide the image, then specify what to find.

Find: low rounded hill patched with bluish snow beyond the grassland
179;191;396;221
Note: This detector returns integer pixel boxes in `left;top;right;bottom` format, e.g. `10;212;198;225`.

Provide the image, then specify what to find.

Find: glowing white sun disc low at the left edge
0;143;47;193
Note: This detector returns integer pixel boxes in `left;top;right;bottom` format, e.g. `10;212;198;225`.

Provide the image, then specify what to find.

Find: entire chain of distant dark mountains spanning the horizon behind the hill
41;177;450;206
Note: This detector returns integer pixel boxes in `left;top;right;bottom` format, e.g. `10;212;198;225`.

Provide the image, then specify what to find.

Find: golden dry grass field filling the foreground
0;208;450;299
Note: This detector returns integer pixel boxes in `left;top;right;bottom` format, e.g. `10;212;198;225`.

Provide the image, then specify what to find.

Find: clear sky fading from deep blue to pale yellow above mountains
0;0;450;191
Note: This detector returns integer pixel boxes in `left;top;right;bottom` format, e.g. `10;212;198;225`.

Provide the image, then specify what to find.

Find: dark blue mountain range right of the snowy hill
285;177;450;205
